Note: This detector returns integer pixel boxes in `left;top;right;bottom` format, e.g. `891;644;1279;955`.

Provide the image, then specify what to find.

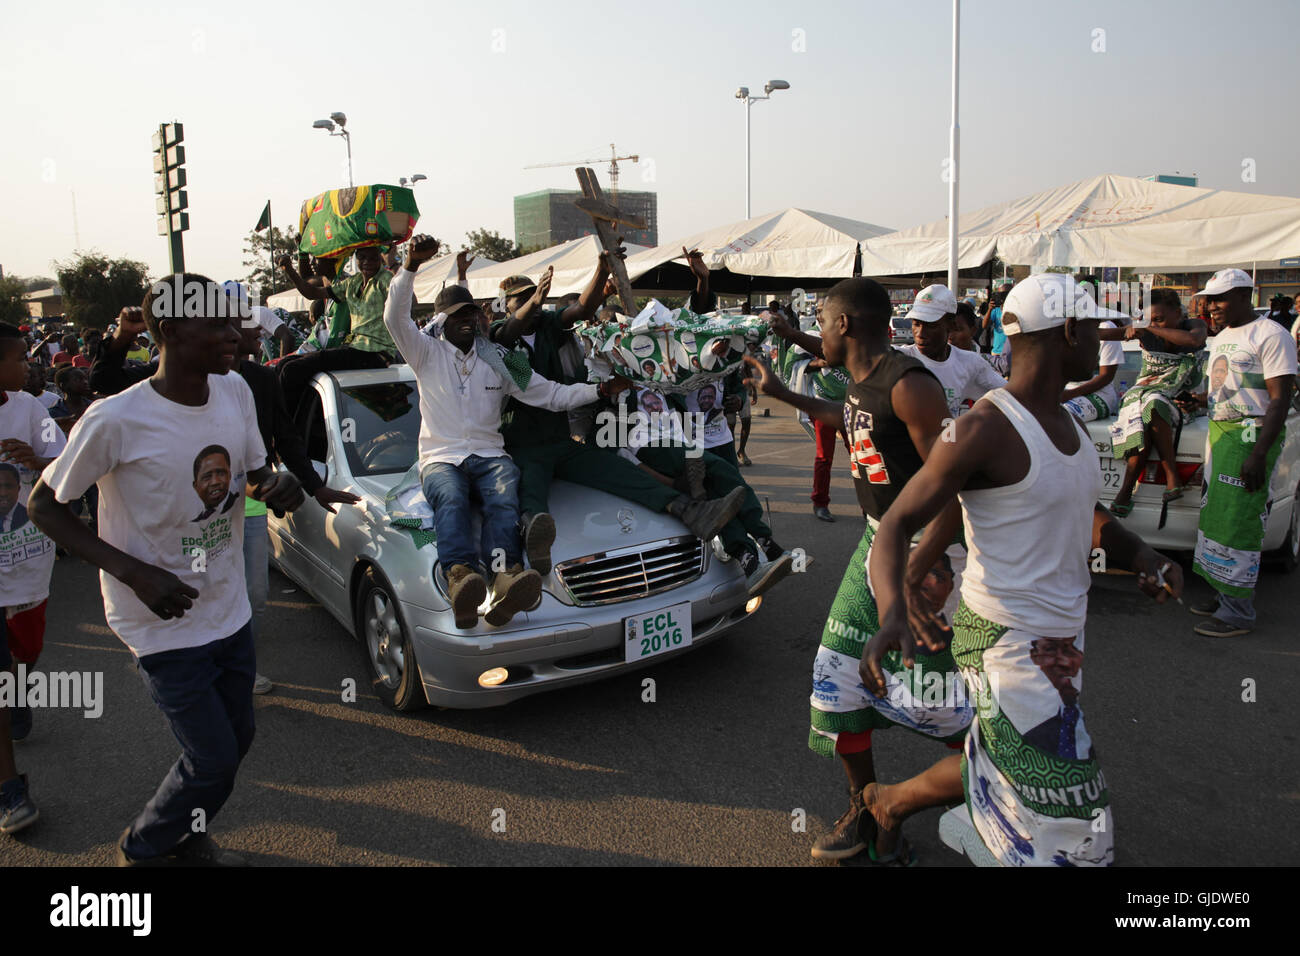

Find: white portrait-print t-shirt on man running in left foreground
42;373;267;657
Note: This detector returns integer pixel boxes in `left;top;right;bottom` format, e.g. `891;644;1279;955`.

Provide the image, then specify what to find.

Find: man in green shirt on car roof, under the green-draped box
280;246;398;412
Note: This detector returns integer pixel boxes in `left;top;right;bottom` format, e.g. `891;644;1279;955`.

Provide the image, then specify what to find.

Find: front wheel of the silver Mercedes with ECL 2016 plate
356;568;428;713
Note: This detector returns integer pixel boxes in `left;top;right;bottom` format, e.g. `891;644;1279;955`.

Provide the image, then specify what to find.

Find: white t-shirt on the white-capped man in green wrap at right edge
1205;316;1296;421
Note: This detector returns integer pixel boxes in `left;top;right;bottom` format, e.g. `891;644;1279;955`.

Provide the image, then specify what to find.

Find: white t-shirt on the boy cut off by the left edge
0;392;66;614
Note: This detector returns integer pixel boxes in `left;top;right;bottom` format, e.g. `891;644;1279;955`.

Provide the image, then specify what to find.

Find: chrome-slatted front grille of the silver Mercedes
555;537;705;607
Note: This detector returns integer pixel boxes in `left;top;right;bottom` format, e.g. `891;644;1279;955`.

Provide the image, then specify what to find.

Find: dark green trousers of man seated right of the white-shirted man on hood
506;440;679;515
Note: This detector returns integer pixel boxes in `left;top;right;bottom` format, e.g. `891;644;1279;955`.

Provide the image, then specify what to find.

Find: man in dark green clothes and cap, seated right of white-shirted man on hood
491;252;744;574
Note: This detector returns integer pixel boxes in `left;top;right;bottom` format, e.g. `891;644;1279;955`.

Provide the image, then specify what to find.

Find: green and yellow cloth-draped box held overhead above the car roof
298;186;420;259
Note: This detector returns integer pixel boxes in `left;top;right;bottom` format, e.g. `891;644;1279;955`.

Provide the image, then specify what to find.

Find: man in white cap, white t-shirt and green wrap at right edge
1191;269;1296;637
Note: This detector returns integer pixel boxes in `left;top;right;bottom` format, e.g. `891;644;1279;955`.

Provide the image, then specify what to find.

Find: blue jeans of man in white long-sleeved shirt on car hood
420;455;524;571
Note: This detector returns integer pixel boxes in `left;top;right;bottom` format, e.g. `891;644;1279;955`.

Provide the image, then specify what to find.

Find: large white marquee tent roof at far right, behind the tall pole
862;176;1300;276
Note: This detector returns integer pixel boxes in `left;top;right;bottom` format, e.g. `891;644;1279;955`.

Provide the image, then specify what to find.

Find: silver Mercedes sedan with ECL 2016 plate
268;365;762;711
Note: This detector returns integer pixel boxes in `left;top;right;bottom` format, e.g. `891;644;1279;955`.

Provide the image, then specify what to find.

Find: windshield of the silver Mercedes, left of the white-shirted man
339;382;420;477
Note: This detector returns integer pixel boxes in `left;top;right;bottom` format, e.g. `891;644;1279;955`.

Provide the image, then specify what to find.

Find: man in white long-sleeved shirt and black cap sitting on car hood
384;235;631;628
